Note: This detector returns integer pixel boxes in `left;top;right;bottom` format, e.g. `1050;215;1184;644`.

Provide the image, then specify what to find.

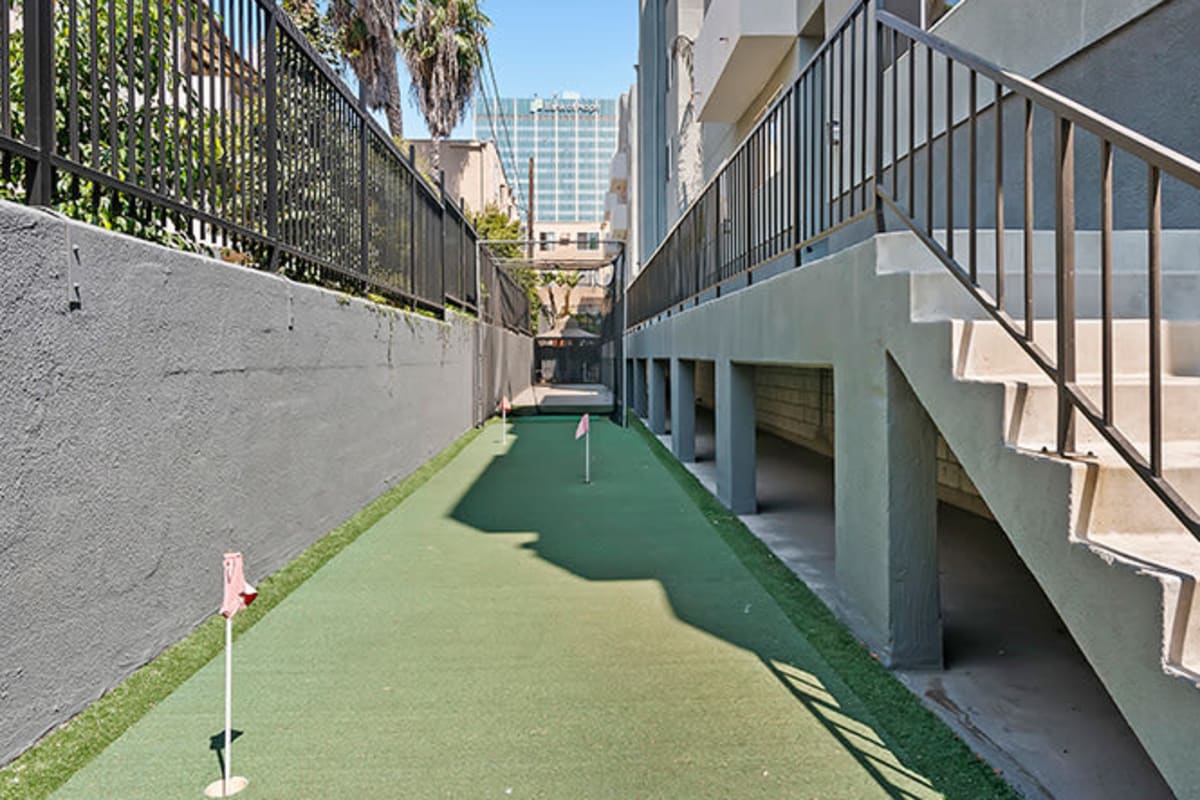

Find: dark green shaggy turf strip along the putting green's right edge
630;416;1020;798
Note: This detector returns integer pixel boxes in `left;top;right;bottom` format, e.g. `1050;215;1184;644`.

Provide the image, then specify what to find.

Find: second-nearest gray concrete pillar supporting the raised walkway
715;360;757;513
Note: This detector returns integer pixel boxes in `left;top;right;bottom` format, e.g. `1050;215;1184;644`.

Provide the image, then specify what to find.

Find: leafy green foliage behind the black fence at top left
0;0;224;249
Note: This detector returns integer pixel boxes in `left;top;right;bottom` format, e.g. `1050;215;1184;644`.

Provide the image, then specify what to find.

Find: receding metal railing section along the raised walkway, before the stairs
628;0;874;325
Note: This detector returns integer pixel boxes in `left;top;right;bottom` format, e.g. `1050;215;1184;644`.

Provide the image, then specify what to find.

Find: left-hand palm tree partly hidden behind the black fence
331;0;404;140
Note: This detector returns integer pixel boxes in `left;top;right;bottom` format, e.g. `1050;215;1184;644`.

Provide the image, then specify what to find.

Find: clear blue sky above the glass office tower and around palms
401;0;637;139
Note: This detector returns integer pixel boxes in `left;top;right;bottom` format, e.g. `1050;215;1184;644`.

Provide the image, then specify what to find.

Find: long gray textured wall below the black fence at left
0;204;533;763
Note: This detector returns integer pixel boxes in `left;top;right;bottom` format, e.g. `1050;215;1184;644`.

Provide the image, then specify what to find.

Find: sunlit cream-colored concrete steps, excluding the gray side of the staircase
954;320;1200;679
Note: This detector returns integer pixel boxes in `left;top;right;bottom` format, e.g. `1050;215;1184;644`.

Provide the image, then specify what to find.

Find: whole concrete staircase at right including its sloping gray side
876;231;1200;796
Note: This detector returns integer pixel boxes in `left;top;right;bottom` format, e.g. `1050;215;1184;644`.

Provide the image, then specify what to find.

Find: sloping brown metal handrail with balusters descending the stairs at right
875;11;1200;539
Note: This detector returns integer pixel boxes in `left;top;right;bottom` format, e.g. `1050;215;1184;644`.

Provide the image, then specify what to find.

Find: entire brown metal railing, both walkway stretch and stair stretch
628;0;1200;537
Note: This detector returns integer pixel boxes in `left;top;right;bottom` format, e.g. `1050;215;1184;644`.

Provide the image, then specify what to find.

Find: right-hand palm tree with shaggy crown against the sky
400;0;492;170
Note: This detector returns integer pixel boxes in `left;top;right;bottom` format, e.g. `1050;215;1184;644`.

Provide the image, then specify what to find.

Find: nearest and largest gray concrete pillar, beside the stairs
834;351;942;669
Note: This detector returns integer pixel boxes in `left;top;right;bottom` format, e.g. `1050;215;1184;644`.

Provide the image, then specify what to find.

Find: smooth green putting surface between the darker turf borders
54;419;940;800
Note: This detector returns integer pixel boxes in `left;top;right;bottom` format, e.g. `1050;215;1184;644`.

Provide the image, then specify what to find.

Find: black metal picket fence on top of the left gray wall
0;0;528;329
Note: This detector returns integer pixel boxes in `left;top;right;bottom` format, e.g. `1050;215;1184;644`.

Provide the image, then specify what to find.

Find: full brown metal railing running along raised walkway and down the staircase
628;0;1200;539
